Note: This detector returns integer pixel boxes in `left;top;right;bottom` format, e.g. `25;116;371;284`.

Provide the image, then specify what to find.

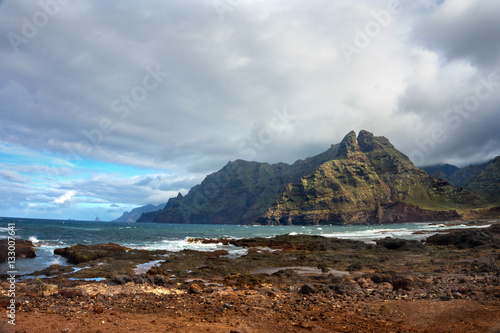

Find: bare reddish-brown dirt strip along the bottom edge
0;280;500;333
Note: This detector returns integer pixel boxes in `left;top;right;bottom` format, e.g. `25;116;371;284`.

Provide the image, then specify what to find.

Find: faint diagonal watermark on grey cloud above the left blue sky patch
67;65;169;161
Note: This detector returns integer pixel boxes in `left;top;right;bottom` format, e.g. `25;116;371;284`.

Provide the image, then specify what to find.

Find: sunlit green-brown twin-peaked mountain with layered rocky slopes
257;131;486;225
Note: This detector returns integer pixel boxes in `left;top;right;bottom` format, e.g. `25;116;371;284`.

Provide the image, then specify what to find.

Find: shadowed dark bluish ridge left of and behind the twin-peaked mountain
143;145;338;224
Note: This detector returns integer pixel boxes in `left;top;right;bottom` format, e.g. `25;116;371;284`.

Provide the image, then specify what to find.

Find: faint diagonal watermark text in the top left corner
7;0;69;53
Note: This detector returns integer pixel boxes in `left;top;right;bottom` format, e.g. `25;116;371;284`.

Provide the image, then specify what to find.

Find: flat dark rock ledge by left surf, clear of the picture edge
54;243;127;264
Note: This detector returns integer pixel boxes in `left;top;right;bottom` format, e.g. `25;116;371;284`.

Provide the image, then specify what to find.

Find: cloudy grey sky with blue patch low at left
0;0;500;220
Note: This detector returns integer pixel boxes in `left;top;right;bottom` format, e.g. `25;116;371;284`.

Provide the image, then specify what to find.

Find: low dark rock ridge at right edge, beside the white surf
426;224;500;249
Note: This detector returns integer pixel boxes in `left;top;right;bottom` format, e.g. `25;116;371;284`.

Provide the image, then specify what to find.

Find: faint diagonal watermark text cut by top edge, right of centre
340;0;403;64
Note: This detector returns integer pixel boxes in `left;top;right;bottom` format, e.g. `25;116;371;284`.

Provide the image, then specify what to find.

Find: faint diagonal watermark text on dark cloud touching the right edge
409;68;500;165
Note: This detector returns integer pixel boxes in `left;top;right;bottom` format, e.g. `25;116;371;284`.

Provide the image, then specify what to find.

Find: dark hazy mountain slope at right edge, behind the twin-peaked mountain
423;156;500;204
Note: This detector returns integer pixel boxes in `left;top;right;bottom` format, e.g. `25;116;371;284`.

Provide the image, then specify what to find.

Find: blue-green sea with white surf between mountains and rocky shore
0;217;486;275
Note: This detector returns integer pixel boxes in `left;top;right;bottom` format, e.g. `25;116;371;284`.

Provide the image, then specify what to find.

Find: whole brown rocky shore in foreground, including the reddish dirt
0;221;500;332
